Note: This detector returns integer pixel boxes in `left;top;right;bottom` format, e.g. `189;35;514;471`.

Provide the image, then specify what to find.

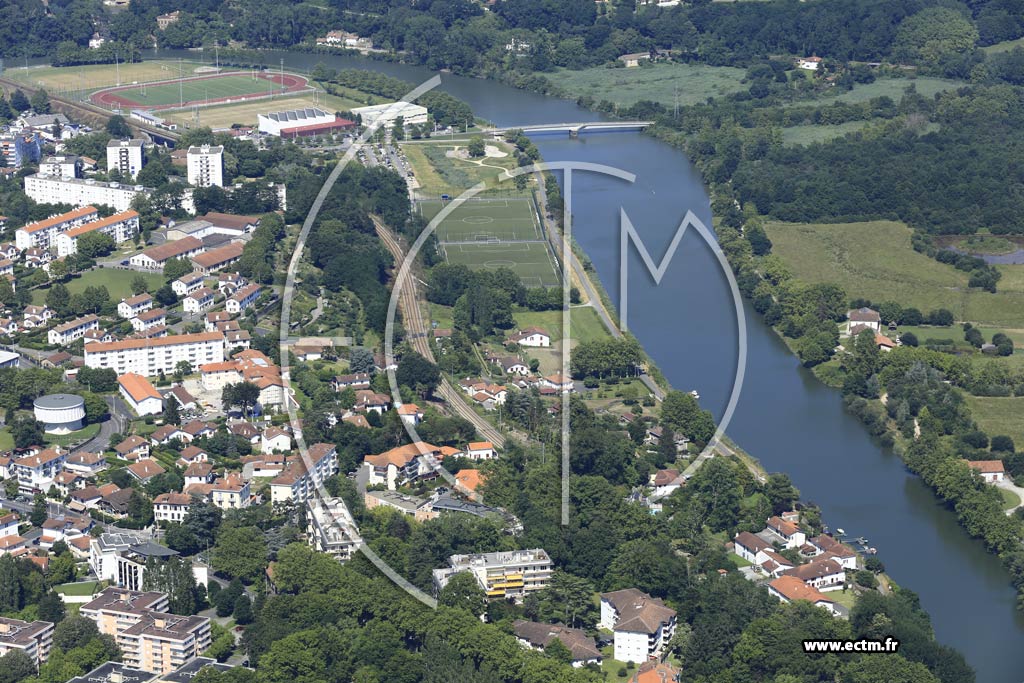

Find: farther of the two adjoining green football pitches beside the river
417;197;544;242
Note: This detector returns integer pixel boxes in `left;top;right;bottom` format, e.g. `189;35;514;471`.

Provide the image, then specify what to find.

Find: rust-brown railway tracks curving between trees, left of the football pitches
374;218;507;449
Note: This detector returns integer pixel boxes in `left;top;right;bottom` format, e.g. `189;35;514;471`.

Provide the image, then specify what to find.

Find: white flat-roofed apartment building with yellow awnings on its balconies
433;548;552;602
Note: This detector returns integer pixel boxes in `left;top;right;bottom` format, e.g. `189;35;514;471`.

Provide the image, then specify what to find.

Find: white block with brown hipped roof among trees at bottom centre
598;588;676;664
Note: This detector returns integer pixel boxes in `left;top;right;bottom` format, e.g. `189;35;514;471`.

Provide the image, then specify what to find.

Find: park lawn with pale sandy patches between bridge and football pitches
401;140;532;198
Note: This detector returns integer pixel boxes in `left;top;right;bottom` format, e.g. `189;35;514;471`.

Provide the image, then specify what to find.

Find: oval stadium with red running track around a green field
91;72;306;109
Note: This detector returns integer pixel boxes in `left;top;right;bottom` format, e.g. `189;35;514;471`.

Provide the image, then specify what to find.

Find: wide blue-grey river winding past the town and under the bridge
151;46;1024;683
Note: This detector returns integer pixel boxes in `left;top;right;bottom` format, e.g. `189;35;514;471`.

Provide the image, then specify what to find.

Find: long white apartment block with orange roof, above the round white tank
85;332;224;377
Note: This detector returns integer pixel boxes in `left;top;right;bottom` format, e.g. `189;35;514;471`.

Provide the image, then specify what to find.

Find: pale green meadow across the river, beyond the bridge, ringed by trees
548;63;746;106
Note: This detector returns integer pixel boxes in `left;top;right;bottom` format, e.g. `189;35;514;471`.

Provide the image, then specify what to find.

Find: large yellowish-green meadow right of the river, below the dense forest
765;221;1024;329
